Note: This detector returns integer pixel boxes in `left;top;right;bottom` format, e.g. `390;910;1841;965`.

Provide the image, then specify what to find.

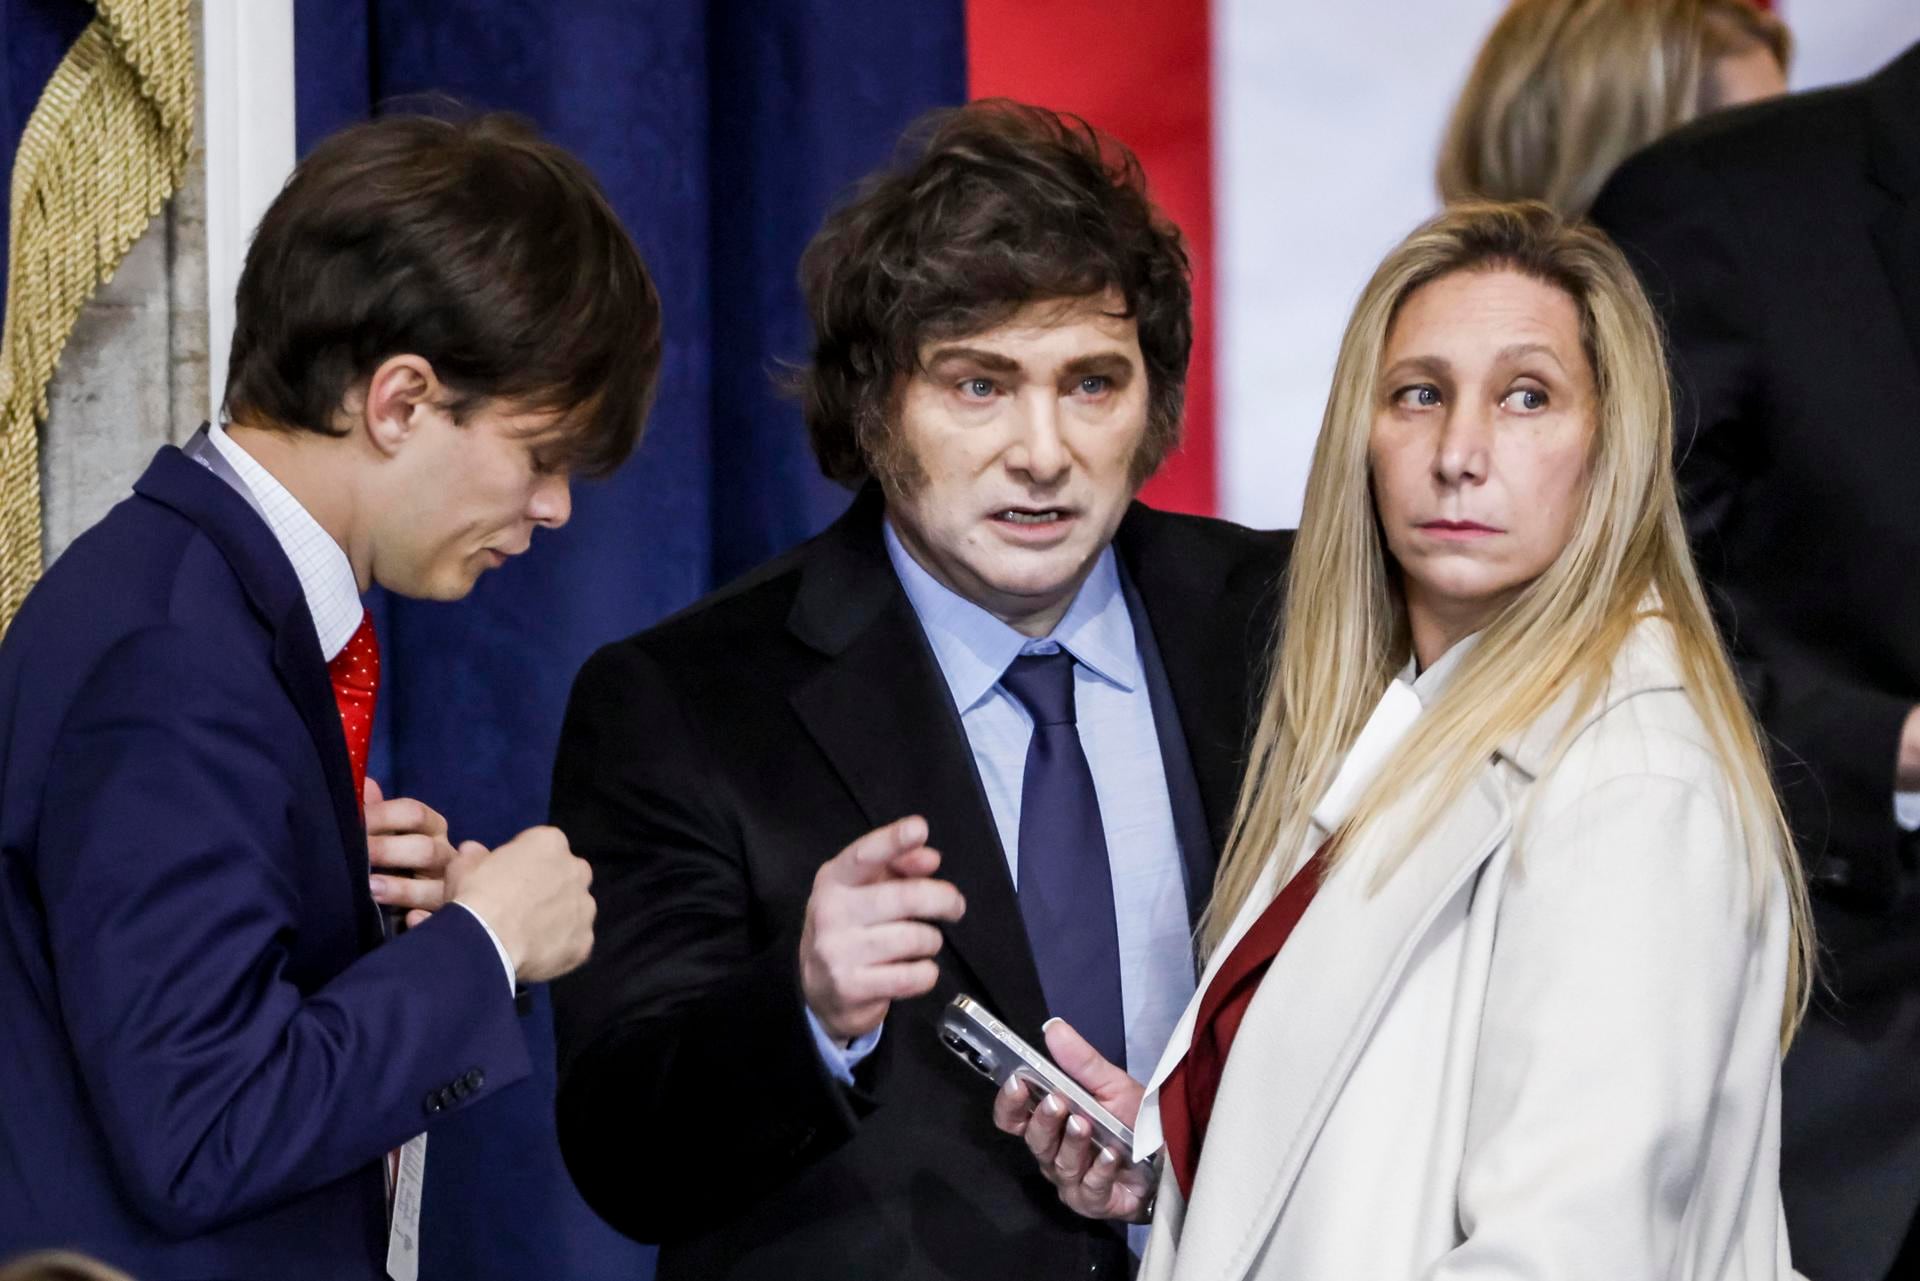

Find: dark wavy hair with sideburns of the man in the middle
795;100;1194;488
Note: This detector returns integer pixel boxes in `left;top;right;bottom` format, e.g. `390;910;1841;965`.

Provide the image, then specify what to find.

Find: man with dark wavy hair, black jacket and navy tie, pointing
553;102;1288;1281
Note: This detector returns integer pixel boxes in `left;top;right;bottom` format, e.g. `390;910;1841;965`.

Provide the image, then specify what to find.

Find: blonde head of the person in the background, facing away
1438;0;1791;217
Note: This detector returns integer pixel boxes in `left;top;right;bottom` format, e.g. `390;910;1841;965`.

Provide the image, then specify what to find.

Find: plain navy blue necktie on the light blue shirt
1000;649;1127;1068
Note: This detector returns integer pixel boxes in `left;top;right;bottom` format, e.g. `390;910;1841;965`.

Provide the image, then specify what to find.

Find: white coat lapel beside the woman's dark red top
1177;770;1511;1279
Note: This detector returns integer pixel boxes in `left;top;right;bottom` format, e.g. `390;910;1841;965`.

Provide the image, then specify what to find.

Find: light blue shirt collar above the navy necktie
883;520;1140;713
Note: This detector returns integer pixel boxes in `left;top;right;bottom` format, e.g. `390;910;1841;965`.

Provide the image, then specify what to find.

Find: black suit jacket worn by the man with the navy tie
553;490;1290;1281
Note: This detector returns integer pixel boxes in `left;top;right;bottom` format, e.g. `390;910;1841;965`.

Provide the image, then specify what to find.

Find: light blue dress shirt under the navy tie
808;524;1194;1083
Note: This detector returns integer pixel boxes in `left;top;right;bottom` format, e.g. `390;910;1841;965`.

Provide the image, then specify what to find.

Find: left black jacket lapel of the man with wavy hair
789;490;1046;1037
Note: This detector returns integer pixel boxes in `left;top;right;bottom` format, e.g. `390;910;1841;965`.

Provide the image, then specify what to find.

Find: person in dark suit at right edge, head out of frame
1594;46;1920;1281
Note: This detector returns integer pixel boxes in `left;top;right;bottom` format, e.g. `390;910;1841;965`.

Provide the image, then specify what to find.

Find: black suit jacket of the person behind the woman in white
1594;46;1920;975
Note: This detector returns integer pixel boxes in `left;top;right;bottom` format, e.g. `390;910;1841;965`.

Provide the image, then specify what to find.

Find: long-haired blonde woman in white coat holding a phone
995;205;1809;1281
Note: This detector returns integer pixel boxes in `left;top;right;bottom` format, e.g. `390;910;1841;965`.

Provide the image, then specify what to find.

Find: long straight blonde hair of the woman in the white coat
1200;202;1812;1045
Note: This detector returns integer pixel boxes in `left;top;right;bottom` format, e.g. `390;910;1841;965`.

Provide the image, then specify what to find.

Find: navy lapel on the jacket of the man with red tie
134;446;380;947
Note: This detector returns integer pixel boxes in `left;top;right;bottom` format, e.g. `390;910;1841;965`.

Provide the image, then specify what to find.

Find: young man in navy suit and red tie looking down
0;117;660;1281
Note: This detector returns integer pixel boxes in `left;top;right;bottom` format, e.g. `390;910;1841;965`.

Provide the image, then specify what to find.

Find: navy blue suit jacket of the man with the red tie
0;447;528;1281
